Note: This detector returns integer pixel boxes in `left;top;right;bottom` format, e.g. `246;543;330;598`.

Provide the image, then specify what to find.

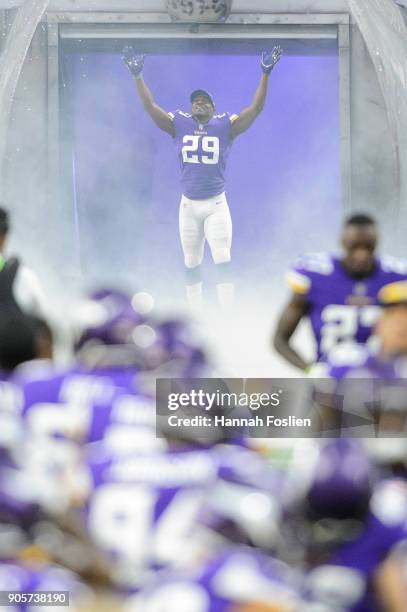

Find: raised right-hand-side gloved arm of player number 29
231;46;282;138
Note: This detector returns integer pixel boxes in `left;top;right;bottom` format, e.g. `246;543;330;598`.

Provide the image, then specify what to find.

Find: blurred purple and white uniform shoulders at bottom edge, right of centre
131;547;302;612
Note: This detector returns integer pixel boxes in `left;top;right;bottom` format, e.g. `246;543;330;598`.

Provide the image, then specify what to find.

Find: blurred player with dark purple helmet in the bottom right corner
282;439;407;612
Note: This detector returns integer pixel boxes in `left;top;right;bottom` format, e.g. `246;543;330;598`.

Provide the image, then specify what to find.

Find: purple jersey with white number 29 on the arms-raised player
169;110;236;200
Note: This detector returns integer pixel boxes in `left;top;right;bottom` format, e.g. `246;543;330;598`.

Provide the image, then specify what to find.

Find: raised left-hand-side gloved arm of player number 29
122;47;174;136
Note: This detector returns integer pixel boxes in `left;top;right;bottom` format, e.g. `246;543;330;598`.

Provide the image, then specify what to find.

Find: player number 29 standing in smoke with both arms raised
123;47;281;308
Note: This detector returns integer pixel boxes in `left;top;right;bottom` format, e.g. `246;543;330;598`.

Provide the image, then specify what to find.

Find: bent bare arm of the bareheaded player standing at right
273;293;310;370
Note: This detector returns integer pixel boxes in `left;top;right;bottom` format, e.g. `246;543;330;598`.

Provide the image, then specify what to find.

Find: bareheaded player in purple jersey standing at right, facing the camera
274;214;407;370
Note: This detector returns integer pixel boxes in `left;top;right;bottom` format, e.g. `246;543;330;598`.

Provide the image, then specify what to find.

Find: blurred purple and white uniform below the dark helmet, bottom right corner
306;480;407;612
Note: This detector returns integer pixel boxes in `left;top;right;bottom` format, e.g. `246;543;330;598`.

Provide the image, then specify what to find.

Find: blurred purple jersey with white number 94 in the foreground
72;433;278;591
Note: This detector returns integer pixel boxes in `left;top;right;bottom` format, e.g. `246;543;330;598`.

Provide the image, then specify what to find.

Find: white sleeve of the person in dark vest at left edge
13;265;51;322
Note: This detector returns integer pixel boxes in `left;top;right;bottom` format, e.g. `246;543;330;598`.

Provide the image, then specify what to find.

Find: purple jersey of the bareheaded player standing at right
287;253;407;360
